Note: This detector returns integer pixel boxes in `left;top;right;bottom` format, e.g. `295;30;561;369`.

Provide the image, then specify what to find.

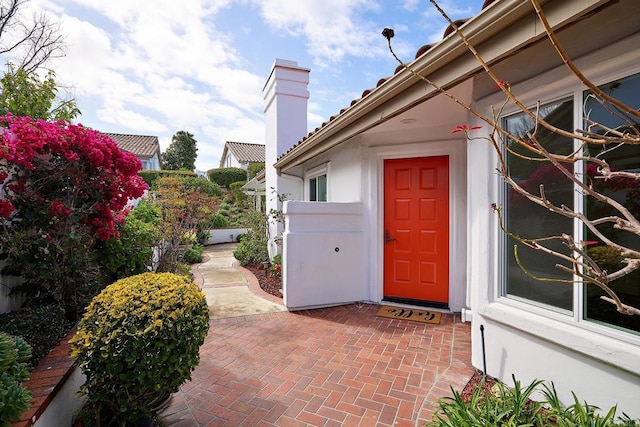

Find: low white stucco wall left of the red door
282;201;368;310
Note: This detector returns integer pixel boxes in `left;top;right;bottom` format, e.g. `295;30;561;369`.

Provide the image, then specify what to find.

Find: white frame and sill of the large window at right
472;36;640;372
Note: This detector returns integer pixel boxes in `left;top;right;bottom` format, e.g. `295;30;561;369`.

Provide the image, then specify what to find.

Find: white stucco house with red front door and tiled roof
264;0;640;417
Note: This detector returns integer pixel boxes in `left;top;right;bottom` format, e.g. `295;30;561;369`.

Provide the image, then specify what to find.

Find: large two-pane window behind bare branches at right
502;74;640;332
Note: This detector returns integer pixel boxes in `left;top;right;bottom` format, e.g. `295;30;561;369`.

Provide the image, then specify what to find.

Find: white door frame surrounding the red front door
363;139;468;312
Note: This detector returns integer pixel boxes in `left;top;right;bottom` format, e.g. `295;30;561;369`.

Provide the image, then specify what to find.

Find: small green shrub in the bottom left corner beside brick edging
0;333;31;427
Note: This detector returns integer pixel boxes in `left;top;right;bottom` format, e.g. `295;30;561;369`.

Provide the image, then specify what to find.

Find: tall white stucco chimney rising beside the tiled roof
262;59;309;256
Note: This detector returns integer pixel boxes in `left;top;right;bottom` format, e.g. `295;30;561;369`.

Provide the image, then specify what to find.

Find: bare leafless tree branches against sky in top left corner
0;0;64;72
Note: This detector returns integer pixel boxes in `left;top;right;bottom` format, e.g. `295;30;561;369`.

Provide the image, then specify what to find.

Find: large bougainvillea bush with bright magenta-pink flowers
0;115;147;305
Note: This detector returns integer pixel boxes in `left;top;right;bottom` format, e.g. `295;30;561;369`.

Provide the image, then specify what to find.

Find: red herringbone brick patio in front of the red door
162;304;474;427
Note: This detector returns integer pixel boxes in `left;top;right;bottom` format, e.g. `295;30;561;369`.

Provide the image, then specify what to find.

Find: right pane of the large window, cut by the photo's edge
584;75;640;332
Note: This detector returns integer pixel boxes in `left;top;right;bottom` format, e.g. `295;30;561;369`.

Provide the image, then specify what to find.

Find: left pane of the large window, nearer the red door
504;100;573;310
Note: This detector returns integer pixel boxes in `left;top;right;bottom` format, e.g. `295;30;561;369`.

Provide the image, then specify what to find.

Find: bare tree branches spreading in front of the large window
382;0;640;315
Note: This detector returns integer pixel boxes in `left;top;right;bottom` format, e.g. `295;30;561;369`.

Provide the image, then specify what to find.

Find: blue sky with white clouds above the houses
13;0;482;170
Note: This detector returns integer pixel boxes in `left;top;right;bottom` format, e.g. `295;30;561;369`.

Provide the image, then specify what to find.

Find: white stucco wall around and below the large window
467;36;640;418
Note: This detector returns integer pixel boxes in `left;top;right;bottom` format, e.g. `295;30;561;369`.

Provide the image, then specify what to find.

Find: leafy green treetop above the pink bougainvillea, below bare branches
0;64;80;122
